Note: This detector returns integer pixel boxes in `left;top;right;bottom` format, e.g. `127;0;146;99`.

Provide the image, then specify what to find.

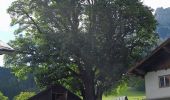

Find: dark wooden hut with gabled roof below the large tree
28;85;81;100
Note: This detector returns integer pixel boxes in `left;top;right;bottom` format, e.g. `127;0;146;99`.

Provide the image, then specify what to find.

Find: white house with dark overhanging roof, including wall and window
128;39;170;100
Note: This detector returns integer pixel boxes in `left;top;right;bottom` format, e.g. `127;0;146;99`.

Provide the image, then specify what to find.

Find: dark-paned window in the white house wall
159;75;170;88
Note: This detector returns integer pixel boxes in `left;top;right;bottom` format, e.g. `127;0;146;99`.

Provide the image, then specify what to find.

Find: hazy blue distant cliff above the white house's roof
155;8;170;40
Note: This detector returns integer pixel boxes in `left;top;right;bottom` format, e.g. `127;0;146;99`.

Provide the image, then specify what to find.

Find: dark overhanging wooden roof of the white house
128;39;170;76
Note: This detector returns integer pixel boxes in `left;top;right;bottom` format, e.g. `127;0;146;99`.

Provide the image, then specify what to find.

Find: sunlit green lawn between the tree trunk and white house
103;90;145;100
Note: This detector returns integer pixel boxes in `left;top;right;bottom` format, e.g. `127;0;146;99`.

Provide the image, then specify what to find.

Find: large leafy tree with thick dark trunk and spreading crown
6;0;157;100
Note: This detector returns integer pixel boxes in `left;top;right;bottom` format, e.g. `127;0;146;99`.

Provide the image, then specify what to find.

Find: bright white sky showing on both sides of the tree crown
0;0;170;66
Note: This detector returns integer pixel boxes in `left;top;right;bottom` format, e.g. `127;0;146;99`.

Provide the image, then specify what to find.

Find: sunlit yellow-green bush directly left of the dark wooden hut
14;92;35;100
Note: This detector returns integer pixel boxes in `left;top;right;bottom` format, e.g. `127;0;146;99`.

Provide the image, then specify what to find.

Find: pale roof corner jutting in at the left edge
0;40;14;55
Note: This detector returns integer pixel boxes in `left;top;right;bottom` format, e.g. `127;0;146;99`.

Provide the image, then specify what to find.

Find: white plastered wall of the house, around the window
145;69;170;100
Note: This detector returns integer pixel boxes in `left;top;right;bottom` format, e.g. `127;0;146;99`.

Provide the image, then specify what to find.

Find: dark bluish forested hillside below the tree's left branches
0;67;36;100
